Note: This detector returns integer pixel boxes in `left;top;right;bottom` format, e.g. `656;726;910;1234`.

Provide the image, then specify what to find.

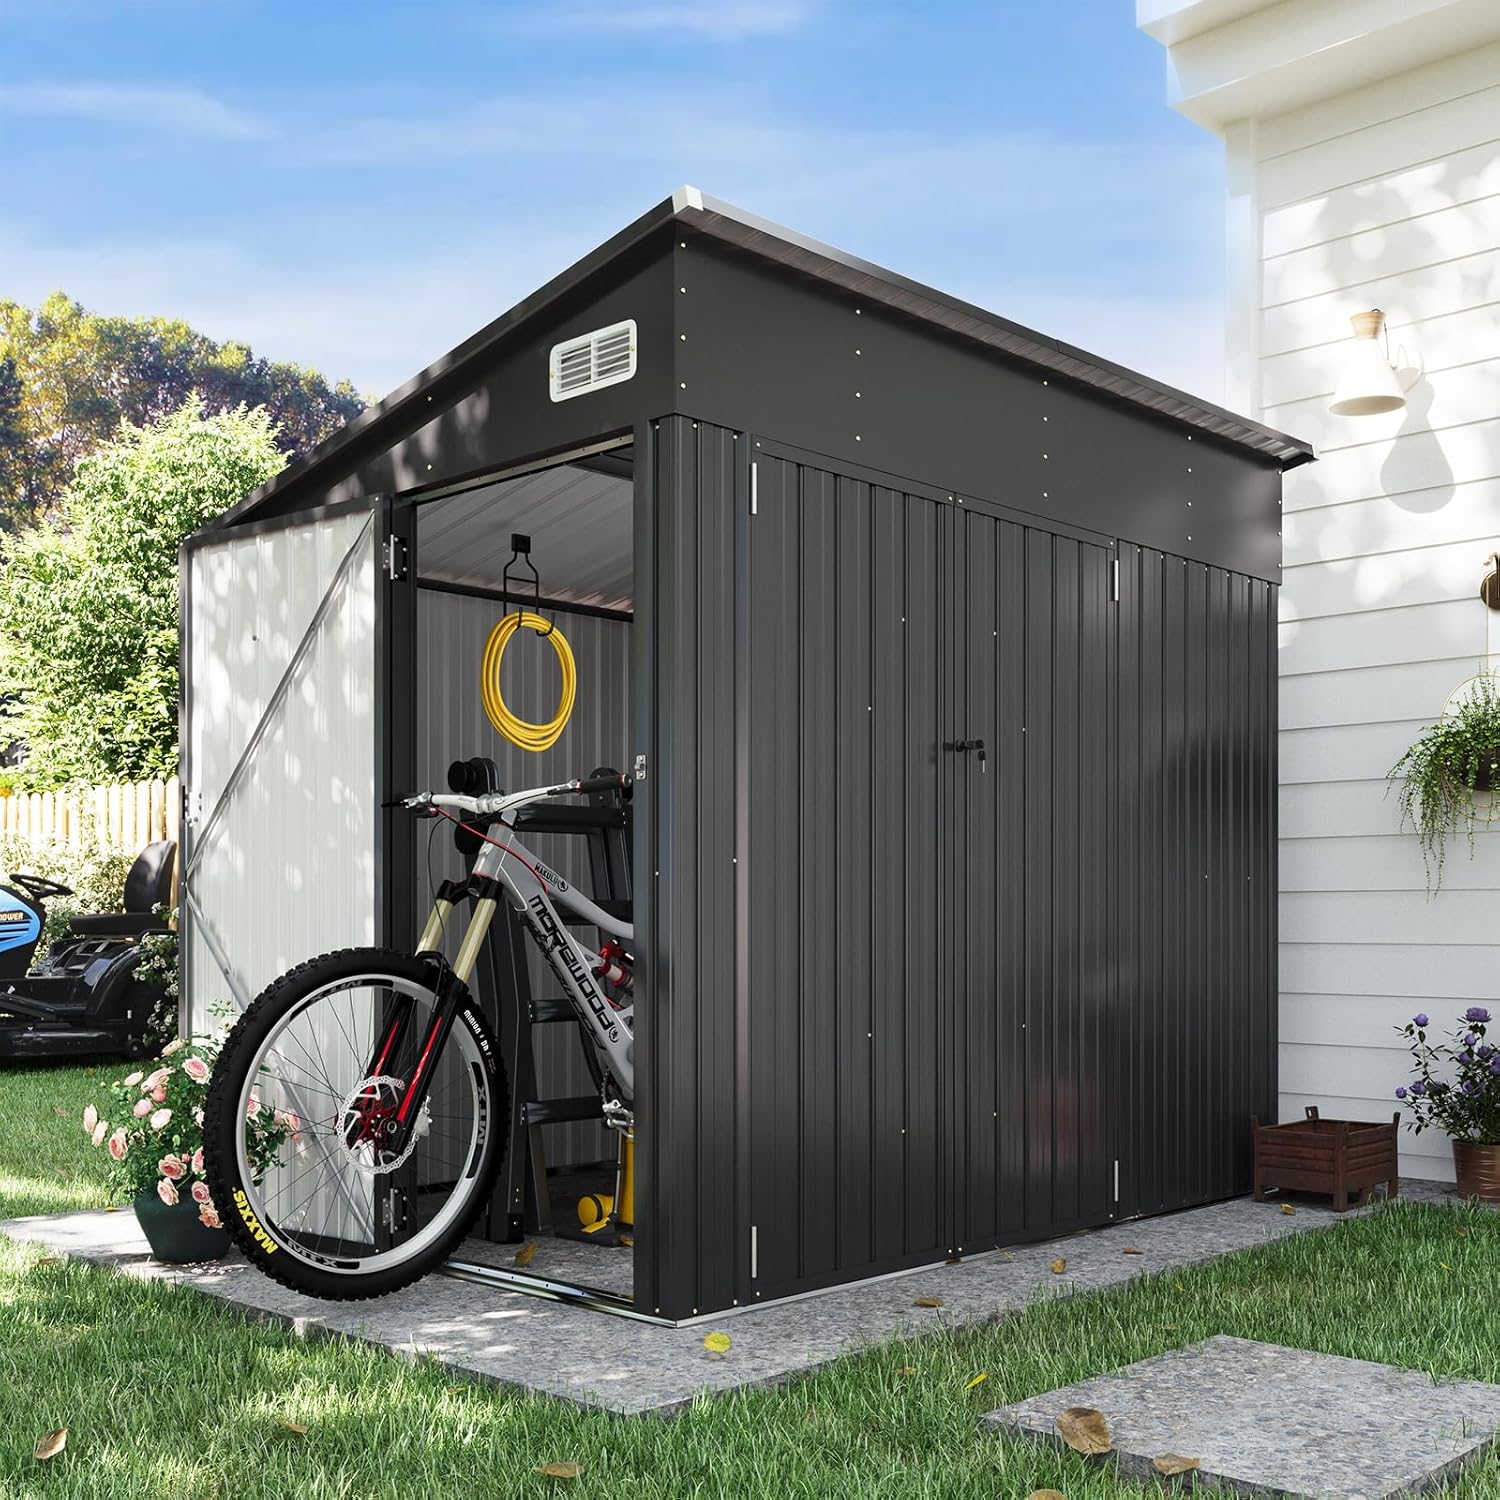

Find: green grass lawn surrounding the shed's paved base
0;1070;1500;1500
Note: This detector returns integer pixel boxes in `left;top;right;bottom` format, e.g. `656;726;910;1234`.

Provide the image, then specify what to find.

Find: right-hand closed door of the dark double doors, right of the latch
953;509;1115;1250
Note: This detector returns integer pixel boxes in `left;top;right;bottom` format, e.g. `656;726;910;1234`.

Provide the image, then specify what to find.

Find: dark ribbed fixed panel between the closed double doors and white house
1112;546;1277;1214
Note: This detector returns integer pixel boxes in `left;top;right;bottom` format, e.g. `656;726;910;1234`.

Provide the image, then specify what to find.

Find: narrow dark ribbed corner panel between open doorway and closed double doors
636;419;749;1317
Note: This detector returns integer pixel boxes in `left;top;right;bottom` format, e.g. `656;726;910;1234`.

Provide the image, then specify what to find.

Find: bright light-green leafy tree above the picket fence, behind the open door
0;398;285;788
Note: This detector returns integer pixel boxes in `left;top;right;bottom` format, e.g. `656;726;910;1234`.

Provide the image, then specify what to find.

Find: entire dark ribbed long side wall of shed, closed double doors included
638;423;1275;1314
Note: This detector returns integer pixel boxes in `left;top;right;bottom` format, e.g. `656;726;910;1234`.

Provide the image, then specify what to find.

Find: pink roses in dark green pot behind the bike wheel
84;1037;299;1263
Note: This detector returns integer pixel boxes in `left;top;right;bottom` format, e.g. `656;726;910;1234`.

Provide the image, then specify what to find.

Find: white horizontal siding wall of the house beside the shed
1241;45;1500;1178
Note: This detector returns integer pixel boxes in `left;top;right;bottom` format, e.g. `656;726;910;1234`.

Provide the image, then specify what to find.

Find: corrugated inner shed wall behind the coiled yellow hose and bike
413;585;632;1166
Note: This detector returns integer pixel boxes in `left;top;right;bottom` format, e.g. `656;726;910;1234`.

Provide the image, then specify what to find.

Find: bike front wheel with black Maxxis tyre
203;948;509;1299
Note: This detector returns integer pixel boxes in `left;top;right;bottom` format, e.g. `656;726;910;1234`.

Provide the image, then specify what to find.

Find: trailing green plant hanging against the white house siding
1386;672;1500;897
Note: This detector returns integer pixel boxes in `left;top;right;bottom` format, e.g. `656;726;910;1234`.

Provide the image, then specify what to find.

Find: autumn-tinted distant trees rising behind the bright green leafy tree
0;291;365;525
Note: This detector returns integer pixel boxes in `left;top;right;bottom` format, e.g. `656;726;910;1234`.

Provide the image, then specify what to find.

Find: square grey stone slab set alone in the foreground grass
983;1337;1500;1500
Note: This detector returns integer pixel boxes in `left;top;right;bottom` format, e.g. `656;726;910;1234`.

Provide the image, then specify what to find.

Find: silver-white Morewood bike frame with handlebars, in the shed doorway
404;782;636;1106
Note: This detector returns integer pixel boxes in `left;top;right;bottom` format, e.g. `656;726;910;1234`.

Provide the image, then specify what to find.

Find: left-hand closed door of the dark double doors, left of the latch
741;456;956;1301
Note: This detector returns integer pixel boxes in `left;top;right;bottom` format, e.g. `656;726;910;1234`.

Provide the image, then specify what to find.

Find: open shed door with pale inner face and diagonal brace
180;503;384;1029
